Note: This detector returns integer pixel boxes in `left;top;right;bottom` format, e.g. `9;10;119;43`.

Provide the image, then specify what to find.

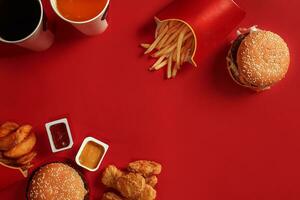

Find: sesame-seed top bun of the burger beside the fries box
237;30;290;89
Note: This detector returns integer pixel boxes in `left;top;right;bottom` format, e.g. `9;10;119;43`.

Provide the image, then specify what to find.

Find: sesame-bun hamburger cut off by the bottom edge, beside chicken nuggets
27;163;88;200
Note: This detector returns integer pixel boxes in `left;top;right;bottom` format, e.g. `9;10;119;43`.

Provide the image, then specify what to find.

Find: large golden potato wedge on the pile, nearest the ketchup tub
3;132;36;158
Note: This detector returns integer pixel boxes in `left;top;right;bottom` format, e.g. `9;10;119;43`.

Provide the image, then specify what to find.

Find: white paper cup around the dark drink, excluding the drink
0;0;54;51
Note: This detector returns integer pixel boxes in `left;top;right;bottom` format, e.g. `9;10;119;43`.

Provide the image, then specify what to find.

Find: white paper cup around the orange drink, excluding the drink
50;0;110;35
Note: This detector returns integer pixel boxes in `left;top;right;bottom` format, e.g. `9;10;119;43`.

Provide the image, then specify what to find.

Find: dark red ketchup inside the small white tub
50;123;70;149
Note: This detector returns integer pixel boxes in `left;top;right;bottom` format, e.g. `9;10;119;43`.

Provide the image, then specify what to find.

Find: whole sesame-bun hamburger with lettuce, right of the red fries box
227;26;290;91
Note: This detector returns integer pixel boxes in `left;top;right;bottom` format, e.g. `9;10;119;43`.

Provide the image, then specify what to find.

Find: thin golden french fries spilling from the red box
141;20;195;79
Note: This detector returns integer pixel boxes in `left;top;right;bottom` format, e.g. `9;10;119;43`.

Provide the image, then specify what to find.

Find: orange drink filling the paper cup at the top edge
56;0;107;22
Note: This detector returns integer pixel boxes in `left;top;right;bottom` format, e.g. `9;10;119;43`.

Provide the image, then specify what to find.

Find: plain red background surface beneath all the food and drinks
0;0;300;200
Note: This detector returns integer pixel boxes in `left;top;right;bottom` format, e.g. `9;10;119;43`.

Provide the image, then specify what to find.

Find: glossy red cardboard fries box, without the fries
156;0;245;66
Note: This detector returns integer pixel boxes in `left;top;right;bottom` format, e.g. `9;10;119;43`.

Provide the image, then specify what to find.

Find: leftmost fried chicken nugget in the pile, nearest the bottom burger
102;165;123;188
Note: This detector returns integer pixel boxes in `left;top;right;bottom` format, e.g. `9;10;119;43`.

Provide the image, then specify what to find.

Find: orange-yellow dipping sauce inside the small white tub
79;141;104;169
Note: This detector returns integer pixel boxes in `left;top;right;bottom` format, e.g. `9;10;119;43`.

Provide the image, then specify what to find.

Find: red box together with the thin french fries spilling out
141;0;245;79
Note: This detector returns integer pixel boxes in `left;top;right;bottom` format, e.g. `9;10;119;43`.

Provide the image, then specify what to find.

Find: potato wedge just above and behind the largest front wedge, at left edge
0;125;32;151
